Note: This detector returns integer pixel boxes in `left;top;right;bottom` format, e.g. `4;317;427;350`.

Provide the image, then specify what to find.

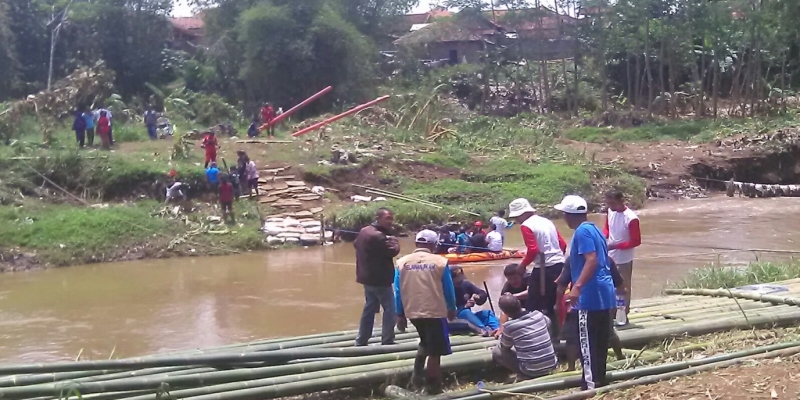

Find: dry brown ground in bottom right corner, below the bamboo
598;355;800;400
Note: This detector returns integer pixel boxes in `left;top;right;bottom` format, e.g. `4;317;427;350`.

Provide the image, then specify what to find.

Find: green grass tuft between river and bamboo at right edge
675;259;800;289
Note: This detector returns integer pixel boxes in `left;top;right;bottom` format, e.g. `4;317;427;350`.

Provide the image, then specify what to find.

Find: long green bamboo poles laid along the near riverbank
0;280;800;400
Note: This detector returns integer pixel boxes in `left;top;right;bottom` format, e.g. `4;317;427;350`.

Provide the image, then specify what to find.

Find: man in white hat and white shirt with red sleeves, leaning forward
508;199;567;337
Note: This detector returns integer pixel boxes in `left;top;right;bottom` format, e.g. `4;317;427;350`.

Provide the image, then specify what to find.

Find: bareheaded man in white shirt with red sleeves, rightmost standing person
603;190;642;320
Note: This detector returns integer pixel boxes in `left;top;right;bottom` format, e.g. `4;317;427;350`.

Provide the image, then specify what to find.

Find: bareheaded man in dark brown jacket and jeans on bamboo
353;208;400;346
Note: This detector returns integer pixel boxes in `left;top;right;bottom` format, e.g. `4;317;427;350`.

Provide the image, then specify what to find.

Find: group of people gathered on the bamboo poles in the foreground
354;191;641;394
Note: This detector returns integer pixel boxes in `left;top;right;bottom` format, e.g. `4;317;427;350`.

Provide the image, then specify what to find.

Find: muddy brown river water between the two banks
0;197;800;362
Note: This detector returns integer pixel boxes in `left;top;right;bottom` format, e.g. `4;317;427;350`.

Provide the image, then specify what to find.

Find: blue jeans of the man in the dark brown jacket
356;285;397;346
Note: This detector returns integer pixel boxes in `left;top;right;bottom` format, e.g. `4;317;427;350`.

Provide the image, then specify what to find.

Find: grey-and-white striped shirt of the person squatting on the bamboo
500;311;558;376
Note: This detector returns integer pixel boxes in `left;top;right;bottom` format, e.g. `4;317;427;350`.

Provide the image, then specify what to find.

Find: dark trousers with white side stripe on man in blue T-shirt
578;310;611;390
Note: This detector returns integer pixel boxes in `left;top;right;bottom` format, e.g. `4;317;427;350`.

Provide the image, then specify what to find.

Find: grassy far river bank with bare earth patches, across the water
0;110;800;271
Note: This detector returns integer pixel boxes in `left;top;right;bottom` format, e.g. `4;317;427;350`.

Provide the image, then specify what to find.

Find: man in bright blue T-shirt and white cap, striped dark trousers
555;196;616;390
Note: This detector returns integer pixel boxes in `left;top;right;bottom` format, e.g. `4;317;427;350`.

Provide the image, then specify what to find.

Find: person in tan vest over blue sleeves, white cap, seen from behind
394;229;457;394
